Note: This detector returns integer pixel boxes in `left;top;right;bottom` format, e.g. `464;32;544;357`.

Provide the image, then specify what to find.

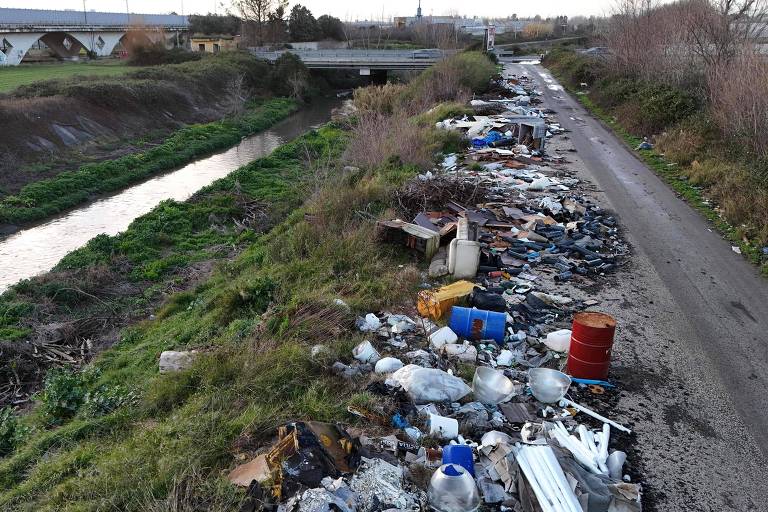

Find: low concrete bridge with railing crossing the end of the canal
251;49;456;75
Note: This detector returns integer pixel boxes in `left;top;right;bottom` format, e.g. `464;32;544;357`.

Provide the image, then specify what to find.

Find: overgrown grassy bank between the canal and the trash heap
0;54;494;511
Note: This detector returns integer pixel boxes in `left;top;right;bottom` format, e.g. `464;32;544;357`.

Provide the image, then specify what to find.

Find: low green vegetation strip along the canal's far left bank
0;98;298;224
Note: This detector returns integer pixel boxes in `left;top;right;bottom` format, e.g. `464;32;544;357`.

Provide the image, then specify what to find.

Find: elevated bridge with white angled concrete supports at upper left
0;8;189;66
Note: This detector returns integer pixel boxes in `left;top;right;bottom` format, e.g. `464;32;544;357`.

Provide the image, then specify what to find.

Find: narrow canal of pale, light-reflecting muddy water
0;99;339;293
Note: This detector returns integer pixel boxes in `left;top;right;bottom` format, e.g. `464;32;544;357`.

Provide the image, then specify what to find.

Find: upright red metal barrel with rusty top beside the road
568;311;616;380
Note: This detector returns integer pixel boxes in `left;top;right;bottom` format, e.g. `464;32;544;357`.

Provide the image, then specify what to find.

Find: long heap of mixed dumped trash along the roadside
229;72;641;512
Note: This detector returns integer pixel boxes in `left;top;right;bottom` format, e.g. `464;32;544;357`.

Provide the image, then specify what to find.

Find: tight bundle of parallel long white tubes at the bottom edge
516;445;584;512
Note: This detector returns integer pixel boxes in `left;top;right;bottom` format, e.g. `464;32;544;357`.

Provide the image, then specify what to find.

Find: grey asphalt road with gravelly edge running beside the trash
505;64;768;511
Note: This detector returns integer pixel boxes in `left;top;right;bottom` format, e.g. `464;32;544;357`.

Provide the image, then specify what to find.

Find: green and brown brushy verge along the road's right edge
544;50;768;274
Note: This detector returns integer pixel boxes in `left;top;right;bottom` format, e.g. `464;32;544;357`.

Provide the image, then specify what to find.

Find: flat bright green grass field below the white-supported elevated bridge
0;60;137;93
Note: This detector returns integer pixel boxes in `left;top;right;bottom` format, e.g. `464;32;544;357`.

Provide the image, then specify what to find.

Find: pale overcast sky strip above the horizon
0;0;615;20
